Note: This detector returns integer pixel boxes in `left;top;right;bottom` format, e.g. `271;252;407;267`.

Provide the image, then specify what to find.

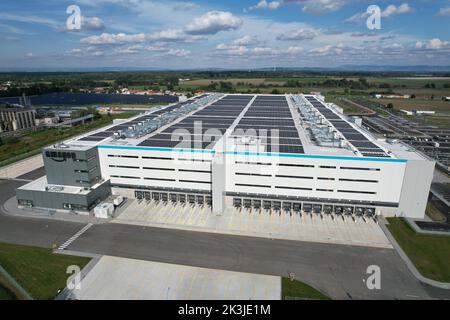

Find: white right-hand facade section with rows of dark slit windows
226;155;406;203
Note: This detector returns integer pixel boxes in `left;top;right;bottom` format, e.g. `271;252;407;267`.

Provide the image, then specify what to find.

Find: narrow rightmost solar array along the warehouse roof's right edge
305;96;389;158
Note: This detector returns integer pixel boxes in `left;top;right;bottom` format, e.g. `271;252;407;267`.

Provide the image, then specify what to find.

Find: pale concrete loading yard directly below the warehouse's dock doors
113;199;391;248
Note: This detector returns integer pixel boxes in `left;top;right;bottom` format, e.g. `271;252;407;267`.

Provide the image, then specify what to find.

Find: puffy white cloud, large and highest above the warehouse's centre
184;11;243;35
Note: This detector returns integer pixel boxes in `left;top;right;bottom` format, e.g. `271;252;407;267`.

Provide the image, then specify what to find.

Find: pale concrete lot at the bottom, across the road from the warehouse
72;256;281;300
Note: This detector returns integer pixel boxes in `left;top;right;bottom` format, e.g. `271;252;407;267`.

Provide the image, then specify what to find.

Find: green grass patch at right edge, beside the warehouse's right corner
387;218;450;282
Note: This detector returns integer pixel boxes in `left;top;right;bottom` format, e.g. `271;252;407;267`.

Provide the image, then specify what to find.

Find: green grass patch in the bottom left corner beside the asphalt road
0;243;90;300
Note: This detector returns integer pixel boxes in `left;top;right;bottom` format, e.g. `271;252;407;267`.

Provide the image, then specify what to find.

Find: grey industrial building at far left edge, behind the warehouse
0;105;36;132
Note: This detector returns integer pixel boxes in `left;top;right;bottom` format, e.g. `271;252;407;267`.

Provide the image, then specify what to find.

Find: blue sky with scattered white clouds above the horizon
0;0;450;69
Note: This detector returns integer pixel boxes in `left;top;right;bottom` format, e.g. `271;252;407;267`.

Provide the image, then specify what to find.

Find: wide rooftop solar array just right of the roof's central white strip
231;95;304;153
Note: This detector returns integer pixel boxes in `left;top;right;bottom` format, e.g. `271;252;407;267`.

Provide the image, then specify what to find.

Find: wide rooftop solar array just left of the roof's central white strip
139;95;253;150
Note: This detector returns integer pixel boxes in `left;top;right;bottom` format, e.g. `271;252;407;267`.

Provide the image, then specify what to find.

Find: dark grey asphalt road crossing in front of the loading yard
0;169;450;299
